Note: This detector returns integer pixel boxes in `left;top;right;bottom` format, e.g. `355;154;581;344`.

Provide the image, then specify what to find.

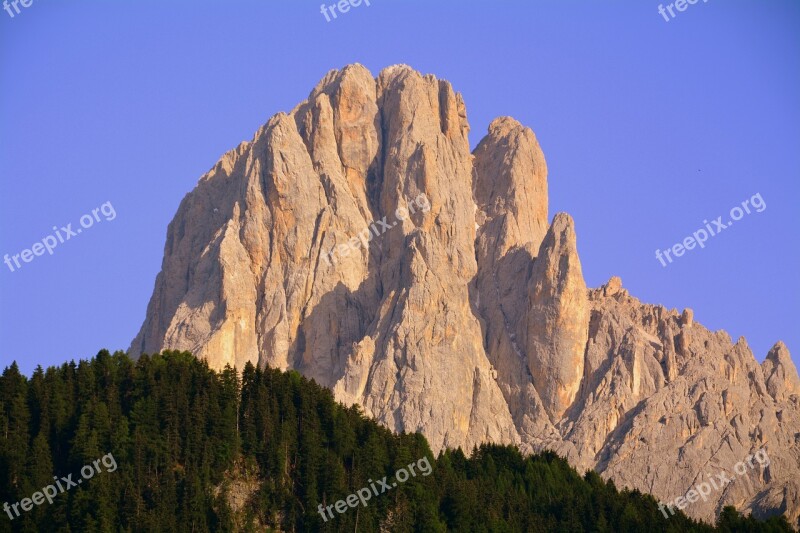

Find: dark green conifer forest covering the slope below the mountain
0;351;792;532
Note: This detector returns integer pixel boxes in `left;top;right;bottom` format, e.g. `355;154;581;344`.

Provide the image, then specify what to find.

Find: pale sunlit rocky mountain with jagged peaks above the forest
130;65;800;519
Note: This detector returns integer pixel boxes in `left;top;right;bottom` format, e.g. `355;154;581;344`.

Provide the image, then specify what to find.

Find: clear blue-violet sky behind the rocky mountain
0;0;800;373
